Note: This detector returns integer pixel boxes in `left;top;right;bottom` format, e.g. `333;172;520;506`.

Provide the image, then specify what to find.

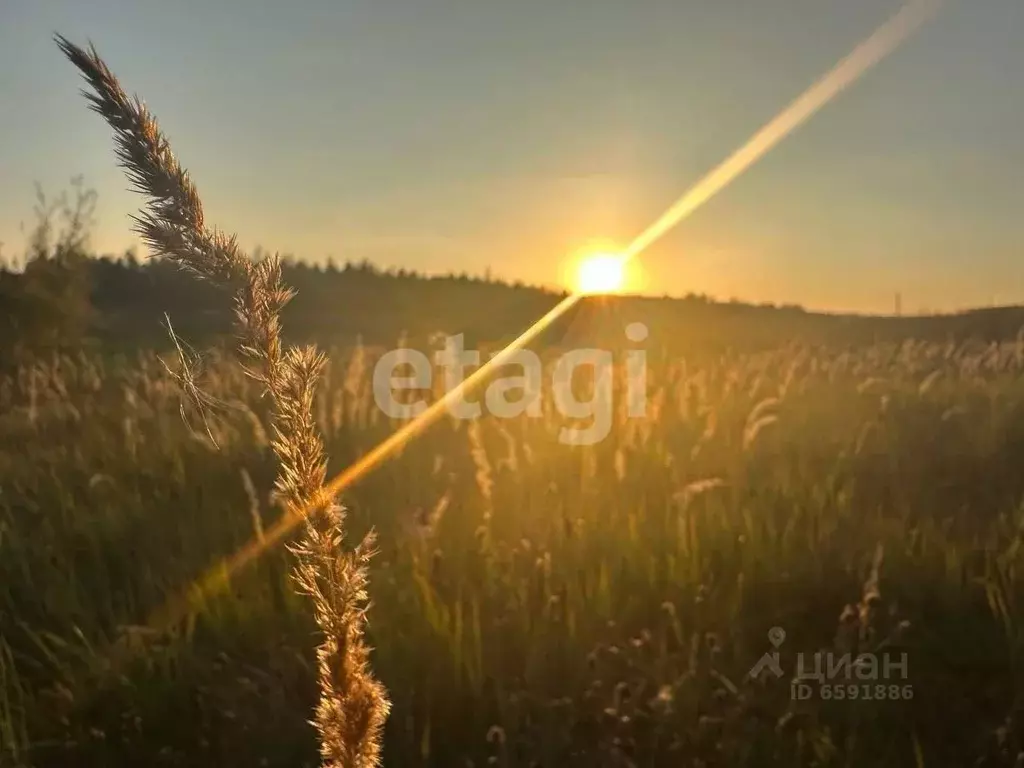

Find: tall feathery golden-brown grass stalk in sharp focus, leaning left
56;36;390;768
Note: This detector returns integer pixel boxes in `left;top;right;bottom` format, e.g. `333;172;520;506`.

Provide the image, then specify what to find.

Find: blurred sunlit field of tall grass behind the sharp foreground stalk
0;341;1024;768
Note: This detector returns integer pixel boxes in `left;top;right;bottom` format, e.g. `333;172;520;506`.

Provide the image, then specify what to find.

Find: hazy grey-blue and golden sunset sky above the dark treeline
0;0;1024;312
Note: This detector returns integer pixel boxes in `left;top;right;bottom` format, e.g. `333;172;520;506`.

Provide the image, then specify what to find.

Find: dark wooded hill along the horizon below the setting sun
6;248;1024;364
